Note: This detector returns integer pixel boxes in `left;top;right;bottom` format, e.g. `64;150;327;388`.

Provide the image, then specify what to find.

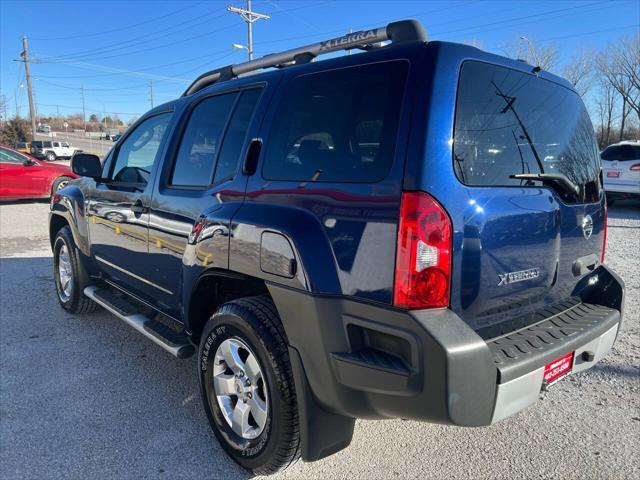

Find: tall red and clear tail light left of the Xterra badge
393;192;452;309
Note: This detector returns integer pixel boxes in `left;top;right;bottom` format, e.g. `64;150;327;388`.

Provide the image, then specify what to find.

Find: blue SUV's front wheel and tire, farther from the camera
53;226;98;313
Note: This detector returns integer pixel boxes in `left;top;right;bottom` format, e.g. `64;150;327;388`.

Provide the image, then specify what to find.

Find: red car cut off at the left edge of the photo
0;144;78;200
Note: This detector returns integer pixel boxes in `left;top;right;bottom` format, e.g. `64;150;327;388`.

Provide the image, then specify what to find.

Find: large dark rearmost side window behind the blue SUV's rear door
262;62;407;182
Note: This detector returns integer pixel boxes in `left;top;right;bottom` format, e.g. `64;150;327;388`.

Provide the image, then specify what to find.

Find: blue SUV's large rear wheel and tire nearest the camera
198;296;300;475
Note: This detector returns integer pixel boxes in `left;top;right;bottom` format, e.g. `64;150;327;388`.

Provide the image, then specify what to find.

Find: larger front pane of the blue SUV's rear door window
170;93;238;187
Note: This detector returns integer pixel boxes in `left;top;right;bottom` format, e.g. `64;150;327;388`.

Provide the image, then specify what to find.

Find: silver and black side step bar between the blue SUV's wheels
84;286;195;358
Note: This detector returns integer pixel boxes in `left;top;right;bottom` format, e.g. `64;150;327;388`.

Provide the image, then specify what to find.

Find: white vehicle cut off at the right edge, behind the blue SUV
600;141;640;203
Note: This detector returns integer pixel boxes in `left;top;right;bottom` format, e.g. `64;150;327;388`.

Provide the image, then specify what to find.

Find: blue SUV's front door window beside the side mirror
111;113;171;185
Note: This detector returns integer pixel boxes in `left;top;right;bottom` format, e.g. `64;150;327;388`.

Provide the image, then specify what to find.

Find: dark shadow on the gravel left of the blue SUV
0;257;252;479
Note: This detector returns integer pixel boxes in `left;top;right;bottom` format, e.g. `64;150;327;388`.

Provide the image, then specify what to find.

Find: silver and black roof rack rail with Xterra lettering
182;20;427;97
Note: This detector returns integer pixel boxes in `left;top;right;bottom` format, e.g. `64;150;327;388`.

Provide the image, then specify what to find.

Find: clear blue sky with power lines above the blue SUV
0;0;640;120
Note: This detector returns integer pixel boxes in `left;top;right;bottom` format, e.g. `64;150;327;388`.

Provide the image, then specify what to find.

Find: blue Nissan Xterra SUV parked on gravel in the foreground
49;21;624;474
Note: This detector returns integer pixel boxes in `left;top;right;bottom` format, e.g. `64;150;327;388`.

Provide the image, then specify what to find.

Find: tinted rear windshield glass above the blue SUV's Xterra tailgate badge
453;62;600;203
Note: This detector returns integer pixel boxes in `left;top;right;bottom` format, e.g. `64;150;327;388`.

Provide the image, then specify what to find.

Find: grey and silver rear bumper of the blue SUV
269;266;624;426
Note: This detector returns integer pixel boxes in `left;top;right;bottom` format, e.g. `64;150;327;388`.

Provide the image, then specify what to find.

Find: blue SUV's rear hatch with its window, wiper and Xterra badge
445;61;605;338
